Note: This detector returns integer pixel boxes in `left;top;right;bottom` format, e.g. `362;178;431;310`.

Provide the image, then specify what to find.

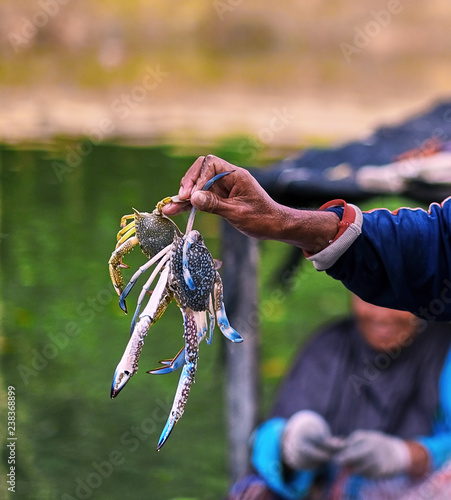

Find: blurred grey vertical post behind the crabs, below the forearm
221;221;259;483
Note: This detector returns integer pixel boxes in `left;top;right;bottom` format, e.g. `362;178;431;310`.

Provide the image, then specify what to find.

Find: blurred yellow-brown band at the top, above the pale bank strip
0;0;451;93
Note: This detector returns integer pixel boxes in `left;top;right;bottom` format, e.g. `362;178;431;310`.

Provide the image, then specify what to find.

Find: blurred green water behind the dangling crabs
0;141;347;500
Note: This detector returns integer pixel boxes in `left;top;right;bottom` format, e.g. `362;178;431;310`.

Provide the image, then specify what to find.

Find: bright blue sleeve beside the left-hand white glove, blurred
252;418;314;500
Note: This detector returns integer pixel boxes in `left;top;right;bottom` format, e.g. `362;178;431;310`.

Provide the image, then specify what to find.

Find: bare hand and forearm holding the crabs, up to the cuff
163;155;340;254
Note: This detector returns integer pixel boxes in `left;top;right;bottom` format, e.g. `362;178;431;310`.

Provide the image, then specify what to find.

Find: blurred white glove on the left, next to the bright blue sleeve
282;410;341;470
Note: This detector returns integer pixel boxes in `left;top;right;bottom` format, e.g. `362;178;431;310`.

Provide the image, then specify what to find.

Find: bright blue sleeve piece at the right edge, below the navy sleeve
417;350;451;470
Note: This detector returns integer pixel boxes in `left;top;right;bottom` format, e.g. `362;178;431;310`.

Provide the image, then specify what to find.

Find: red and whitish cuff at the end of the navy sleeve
304;200;363;271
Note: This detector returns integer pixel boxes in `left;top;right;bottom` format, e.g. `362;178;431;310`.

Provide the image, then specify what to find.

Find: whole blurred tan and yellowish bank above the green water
0;0;451;147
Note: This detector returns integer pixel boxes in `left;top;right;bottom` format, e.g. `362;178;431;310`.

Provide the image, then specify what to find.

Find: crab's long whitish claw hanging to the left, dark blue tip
111;268;172;398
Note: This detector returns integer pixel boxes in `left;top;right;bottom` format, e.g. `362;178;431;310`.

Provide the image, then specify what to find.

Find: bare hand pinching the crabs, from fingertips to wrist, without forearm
163;155;284;239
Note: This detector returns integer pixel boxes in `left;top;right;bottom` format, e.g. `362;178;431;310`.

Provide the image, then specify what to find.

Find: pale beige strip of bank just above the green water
0;83;449;149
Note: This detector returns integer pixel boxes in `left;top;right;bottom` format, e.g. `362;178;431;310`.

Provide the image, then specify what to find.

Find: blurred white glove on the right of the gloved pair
334;430;411;478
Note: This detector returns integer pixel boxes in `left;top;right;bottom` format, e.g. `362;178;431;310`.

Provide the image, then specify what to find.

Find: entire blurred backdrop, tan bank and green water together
0;0;451;500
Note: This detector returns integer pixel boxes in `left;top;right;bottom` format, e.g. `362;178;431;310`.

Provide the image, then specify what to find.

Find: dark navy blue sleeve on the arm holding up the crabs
327;198;451;321
